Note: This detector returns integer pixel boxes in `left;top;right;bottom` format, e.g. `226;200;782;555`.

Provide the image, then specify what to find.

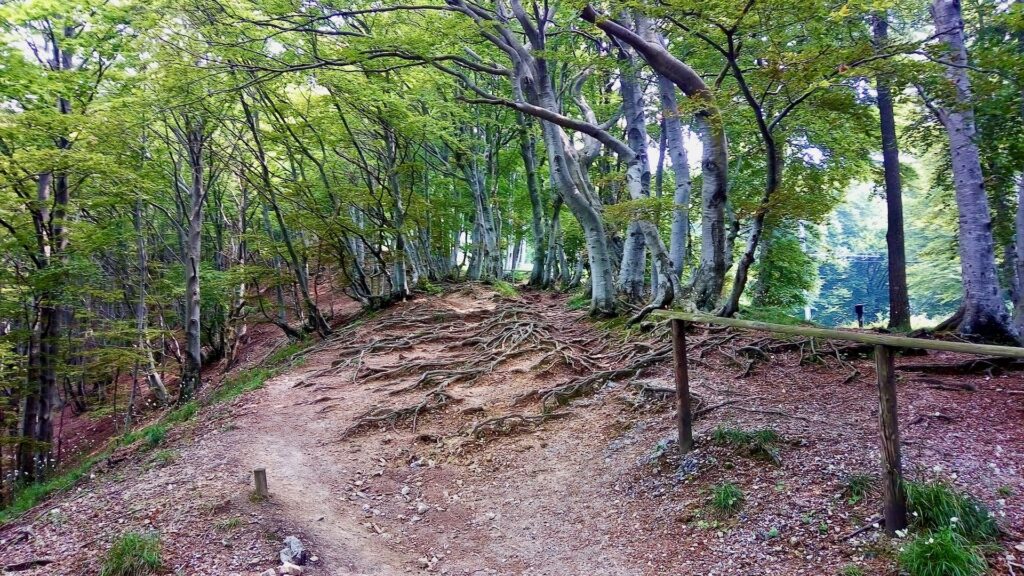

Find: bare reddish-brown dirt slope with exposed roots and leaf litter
0;285;1024;576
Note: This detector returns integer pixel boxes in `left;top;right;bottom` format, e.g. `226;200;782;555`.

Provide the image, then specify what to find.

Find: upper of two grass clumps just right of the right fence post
904;482;999;544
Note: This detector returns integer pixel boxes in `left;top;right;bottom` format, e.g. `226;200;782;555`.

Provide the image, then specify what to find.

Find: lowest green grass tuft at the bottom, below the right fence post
899;526;988;576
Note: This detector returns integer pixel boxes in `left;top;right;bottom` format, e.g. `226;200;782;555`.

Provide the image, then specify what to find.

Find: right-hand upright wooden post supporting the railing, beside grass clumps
874;345;906;534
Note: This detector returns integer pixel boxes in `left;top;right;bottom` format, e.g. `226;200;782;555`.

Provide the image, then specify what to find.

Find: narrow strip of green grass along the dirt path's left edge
0;339;311;522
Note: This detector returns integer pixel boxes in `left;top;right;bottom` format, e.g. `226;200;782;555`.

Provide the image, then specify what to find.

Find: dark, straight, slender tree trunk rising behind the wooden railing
871;12;910;330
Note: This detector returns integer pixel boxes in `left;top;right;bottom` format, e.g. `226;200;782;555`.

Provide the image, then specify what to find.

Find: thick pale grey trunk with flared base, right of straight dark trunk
932;0;1018;341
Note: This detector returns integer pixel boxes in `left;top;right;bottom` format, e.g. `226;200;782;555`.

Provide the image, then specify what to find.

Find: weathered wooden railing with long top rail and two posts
651;310;1024;533
